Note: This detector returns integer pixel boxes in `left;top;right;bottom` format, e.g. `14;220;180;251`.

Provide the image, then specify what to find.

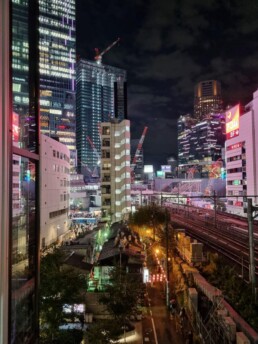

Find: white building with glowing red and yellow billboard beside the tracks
225;90;258;215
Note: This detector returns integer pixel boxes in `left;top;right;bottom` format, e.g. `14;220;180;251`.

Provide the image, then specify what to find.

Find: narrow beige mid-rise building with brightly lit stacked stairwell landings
101;120;131;221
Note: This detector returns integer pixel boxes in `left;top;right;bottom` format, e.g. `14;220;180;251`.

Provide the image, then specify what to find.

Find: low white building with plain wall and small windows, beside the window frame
40;135;70;248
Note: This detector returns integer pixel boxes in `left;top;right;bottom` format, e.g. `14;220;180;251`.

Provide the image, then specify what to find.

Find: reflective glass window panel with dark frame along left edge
10;0;40;344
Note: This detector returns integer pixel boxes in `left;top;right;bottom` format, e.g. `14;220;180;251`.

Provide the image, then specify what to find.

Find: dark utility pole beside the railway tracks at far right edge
247;198;258;302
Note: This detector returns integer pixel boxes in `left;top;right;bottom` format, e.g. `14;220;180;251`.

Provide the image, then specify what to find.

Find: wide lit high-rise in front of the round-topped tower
178;114;225;178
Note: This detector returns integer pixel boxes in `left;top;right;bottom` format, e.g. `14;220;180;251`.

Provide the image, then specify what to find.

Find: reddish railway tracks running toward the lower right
168;206;258;280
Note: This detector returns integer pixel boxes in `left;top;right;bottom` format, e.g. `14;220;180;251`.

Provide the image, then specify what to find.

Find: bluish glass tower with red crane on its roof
76;59;127;173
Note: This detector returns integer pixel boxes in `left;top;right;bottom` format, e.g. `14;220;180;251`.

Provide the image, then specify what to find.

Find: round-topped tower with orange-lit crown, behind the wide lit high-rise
194;80;223;120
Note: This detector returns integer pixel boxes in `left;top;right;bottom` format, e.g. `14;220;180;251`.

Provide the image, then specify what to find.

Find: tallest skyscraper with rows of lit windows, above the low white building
39;0;76;165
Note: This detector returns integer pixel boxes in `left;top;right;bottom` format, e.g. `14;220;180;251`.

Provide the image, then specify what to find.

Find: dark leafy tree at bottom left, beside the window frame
40;249;86;342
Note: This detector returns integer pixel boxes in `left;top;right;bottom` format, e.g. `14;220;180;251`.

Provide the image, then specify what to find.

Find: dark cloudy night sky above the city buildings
77;0;258;167
